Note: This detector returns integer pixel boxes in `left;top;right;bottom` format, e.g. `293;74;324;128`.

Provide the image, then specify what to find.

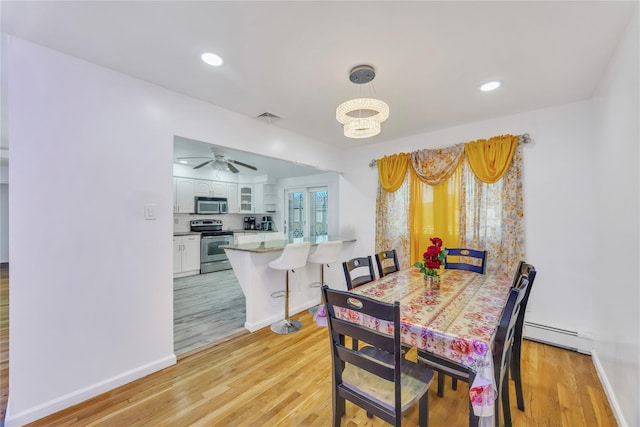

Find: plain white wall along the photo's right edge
593;7;640;426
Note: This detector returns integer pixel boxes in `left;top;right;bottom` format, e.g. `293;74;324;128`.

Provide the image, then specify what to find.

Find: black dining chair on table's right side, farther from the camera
511;261;536;411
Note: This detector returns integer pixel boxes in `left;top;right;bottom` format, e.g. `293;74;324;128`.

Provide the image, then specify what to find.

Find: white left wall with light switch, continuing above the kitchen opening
3;37;341;426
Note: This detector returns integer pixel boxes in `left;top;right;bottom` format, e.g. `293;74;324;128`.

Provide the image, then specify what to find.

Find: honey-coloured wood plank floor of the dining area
0;266;617;427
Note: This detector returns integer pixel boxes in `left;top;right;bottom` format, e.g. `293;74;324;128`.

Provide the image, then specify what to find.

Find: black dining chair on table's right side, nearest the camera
418;278;529;427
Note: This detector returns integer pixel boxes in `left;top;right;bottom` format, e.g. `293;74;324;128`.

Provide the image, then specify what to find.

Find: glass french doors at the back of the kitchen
285;187;329;241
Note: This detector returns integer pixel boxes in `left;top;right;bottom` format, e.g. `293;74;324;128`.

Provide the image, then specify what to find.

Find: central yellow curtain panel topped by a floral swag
409;148;464;264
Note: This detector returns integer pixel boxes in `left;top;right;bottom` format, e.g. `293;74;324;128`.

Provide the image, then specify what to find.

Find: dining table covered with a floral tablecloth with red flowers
336;268;511;425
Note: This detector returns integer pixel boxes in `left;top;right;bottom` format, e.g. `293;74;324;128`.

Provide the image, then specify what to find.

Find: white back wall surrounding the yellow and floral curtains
341;101;595;337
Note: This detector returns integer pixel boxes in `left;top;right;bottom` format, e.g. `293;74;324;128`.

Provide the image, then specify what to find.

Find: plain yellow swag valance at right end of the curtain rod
464;135;518;184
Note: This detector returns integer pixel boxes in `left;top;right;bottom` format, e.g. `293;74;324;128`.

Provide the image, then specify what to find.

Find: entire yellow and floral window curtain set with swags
376;135;524;275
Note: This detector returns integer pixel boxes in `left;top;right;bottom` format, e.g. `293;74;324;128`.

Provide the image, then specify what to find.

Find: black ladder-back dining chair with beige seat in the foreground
322;286;433;427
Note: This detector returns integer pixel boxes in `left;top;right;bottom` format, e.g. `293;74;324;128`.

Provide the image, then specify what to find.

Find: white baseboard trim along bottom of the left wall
4;355;176;427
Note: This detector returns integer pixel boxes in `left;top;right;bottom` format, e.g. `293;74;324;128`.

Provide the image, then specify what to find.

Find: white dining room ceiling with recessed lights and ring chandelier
0;0;637;174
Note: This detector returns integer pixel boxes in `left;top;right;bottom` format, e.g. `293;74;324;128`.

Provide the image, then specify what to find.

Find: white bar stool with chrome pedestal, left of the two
268;242;311;334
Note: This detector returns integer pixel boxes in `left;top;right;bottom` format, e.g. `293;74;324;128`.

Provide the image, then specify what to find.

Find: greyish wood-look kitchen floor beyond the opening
173;270;247;356
